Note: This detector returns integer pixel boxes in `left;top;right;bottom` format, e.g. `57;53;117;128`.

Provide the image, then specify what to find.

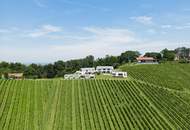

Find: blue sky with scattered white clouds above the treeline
0;0;190;63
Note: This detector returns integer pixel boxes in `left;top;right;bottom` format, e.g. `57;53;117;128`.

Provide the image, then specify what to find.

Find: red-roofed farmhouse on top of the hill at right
137;56;158;64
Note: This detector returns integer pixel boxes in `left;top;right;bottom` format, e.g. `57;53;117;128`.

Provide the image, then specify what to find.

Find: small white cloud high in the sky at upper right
130;16;153;25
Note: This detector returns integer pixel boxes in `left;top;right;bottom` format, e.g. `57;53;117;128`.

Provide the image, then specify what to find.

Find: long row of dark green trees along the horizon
0;49;189;78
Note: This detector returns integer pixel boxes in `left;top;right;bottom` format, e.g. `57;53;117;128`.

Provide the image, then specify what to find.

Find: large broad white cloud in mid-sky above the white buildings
46;27;137;58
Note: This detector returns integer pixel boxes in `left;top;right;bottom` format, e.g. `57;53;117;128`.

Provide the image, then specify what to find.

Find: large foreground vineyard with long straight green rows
0;80;190;130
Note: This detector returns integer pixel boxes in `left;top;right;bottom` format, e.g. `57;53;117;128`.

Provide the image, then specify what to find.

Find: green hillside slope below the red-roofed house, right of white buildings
120;63;190;90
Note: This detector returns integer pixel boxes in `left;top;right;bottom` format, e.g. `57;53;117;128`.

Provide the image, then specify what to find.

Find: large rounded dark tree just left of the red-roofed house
119;51;140;63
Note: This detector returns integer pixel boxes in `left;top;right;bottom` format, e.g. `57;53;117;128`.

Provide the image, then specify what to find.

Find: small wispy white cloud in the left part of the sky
26;25;62;37
